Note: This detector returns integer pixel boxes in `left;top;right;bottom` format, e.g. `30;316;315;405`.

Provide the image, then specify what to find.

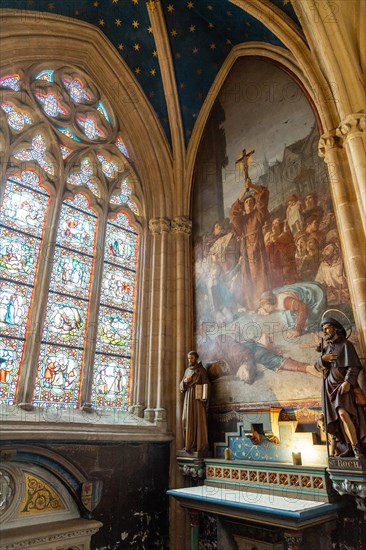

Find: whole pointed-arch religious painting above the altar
193;58;355;405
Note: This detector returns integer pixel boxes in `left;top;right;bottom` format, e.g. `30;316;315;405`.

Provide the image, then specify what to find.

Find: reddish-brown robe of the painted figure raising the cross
230;186;269;311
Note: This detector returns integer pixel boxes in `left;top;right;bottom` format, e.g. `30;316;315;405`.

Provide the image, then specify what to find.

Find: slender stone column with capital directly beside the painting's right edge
319;130;366;353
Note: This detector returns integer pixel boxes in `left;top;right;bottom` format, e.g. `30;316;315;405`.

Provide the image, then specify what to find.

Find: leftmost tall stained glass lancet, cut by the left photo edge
0;170;49;405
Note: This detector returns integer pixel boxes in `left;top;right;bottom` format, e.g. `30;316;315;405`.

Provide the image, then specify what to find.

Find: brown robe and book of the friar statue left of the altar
179;363;209;453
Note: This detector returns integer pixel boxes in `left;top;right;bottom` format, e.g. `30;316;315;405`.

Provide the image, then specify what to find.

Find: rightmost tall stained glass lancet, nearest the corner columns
92;214;138;410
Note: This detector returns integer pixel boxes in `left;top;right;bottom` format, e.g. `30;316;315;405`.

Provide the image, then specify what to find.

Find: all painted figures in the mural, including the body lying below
195;179;349;384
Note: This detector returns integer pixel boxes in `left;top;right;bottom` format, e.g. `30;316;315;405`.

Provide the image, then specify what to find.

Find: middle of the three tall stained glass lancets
34;195;97;407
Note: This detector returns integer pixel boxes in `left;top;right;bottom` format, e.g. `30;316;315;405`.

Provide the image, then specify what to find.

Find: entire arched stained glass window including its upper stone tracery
0;66;138;410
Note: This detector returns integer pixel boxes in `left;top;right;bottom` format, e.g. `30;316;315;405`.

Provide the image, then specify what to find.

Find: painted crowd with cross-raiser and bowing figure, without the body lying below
195;180;349;337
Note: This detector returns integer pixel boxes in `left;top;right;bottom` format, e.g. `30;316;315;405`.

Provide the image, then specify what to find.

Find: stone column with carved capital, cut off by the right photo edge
336;112;366;231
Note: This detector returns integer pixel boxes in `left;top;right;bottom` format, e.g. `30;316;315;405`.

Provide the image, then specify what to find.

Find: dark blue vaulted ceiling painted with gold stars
1;0;301;143
